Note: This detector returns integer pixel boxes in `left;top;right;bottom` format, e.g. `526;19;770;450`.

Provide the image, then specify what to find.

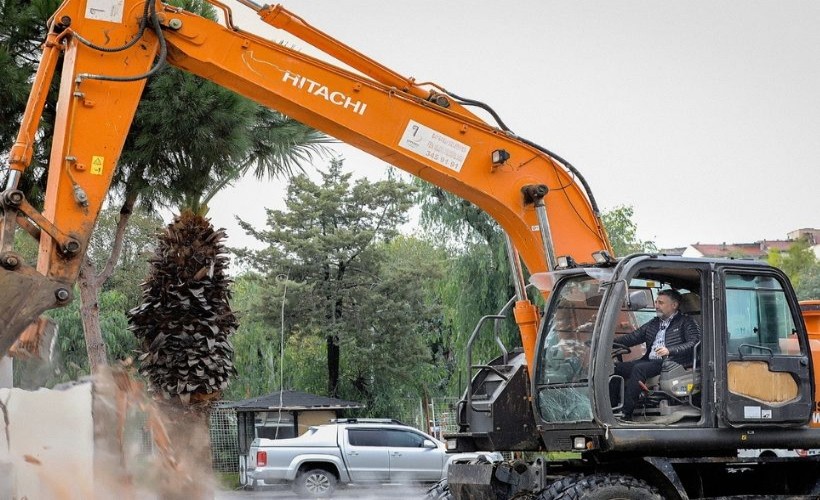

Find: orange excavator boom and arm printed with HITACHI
0;0;611;362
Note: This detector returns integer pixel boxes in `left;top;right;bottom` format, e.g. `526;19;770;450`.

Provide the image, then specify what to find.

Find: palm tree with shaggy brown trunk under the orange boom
121;0;331;498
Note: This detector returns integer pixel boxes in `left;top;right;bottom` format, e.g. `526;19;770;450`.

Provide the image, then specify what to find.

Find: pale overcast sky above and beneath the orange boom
210;0;820;254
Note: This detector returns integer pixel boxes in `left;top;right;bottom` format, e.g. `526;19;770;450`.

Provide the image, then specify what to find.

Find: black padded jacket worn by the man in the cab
615;312;700;366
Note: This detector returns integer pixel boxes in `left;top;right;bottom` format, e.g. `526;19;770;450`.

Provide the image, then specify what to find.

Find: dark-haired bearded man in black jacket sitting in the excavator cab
609;289;701;420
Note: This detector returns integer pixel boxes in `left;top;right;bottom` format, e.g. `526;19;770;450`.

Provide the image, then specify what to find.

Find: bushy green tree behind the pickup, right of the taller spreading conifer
350;237;454;415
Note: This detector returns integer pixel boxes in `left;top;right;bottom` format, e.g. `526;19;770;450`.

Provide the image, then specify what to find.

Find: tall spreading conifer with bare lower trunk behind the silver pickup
238;161;417;397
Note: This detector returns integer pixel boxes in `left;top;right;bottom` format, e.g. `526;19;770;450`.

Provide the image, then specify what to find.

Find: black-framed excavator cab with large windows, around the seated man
532;255;814;454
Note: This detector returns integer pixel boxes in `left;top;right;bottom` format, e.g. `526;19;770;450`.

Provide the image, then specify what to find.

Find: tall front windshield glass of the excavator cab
536;275;603;422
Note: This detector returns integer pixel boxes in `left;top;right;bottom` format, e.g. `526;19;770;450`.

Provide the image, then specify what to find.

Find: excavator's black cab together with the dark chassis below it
445;255;820;498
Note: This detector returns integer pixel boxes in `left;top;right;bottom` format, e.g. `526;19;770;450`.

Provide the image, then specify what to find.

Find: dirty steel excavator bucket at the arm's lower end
0;268;71;355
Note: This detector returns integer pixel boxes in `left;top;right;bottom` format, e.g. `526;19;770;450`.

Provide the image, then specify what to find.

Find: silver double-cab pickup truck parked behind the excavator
247;419;494;497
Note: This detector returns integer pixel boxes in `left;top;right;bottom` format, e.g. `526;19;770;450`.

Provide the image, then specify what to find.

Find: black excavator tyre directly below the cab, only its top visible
542;474;663;500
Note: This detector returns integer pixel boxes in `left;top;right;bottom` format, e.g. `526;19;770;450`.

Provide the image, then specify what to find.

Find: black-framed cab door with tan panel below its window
716;267;813;427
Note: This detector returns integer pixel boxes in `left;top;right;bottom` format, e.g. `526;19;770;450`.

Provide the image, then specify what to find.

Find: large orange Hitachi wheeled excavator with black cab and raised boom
0;0;820;499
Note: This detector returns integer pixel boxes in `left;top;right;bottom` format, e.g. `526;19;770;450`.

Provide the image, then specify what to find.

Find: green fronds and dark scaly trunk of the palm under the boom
121;0;327;403
